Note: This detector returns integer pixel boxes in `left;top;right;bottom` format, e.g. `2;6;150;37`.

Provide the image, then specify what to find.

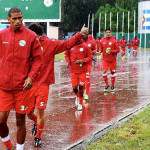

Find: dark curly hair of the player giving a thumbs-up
28;23;44;35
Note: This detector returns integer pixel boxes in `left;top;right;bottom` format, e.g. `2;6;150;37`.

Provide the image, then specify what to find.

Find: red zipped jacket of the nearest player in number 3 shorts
0;25;43;90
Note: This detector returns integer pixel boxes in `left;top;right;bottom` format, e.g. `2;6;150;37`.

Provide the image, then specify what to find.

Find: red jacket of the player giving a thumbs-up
34;33;82;86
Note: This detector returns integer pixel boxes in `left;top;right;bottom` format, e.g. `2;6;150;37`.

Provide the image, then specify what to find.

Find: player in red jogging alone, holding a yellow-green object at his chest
100;29;120;92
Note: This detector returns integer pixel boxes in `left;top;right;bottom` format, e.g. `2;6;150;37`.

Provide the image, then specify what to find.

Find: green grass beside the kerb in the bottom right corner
86;107;150;150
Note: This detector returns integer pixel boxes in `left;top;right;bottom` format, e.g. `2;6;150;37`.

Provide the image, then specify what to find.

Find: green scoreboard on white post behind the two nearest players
0;0;61;39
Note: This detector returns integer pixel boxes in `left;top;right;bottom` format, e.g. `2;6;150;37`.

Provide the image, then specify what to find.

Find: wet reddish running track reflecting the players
0;50;150;150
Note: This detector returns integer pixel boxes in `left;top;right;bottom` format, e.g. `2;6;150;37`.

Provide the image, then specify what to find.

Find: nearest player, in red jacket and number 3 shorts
0;8;43;150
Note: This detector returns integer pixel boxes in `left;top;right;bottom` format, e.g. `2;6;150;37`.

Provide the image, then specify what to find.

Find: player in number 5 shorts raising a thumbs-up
28;23;88;147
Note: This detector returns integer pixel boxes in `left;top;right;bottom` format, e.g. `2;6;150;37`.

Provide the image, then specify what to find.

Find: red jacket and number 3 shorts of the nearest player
0;25;43;114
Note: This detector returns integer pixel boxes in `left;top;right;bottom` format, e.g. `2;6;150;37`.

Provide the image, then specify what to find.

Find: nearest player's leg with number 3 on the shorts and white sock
14;90;34;150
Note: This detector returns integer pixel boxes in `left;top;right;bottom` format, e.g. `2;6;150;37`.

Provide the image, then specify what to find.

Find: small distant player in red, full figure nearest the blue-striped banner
131;36;140;57
